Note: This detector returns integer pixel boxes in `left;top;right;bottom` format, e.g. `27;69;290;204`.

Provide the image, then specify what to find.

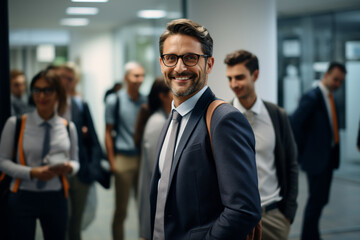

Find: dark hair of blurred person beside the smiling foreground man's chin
148;77;170;114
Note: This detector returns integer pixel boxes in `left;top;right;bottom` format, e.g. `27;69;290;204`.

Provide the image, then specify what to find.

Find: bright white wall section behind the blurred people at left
69;31;114;145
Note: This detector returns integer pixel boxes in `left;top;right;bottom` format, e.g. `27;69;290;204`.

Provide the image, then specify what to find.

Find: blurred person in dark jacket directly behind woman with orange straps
50;63;110;240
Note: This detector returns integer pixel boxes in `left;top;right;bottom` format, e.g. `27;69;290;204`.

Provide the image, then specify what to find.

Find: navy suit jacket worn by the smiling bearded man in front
150;89;261;240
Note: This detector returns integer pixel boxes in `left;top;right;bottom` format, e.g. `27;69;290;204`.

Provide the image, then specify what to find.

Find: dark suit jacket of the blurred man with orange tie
290;87;339;174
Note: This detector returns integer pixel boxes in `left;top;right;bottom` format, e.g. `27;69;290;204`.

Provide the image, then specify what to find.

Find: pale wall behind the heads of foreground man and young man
188;0;277;102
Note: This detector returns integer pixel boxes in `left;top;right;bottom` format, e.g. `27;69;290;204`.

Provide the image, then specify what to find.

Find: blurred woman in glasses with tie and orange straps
0;70;79;240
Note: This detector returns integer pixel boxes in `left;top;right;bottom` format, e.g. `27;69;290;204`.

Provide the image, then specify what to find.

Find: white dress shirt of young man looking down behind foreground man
234;97;282;207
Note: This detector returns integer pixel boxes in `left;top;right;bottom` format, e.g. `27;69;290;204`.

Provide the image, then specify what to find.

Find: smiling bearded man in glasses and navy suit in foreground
150;19;261;240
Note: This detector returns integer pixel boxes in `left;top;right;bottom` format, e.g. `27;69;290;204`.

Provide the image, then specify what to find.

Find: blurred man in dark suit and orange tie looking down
290;62;346;240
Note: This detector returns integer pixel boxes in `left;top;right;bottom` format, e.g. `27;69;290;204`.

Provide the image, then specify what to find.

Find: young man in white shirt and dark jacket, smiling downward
225;50;298;240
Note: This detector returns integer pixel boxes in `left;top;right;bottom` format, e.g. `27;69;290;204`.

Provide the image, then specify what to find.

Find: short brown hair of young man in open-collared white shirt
224;50;259;74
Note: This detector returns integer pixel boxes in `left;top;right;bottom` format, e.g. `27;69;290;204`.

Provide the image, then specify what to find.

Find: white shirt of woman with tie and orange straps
0;110;79;191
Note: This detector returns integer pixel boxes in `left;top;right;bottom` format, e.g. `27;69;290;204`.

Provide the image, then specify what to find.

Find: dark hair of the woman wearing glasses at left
30;69;66;115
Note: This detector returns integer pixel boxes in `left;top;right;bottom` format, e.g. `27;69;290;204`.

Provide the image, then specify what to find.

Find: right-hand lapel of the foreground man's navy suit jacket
168;88;215;186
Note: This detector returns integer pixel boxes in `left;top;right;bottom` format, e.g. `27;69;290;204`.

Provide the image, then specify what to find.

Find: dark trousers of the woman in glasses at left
8;190;68;240
